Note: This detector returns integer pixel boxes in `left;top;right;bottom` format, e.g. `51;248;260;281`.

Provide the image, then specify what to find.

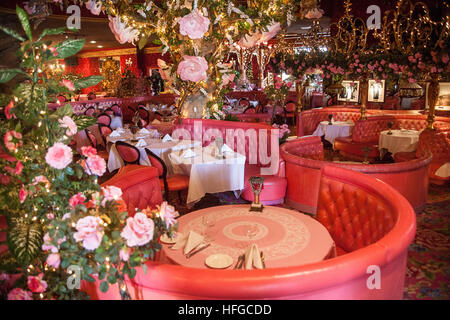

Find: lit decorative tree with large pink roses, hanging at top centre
83;0;299;118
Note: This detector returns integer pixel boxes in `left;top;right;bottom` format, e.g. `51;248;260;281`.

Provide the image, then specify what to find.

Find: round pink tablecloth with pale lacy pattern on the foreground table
162;205;335;268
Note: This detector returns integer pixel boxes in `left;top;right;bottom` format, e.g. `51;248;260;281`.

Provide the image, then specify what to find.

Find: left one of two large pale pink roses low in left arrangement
73;216;104;250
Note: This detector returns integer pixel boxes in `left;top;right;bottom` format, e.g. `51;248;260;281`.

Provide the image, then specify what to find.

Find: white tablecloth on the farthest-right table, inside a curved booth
378;129;420;155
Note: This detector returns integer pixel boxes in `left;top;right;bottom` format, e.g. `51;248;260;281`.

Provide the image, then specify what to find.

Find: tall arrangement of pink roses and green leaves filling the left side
0;7;178;299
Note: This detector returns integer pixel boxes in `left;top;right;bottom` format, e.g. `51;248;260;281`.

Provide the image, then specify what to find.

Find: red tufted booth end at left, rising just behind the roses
101;165;162;215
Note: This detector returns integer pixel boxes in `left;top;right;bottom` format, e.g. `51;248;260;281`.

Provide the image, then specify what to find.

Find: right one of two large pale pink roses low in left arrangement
120;212;155;247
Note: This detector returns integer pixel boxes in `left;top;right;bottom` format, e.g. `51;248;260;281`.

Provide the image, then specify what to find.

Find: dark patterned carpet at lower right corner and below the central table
170;185;450;300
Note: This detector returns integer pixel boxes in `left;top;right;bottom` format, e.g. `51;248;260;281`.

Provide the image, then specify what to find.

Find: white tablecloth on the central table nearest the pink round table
169;145;245;205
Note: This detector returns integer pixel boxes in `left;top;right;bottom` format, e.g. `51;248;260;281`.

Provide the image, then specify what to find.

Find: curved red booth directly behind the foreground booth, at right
280;136;432;214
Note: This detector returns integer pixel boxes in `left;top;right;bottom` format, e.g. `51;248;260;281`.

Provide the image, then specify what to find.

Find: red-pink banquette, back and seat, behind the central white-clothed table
173;119;287;205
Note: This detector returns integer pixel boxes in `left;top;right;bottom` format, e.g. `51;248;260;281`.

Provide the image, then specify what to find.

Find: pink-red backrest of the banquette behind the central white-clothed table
172;119;279;165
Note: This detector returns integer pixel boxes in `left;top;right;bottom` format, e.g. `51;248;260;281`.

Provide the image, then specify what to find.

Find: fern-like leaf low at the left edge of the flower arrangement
7;218;42;266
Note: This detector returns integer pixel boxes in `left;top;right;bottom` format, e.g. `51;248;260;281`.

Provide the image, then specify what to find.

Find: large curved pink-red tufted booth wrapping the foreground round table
82;166;416;299
